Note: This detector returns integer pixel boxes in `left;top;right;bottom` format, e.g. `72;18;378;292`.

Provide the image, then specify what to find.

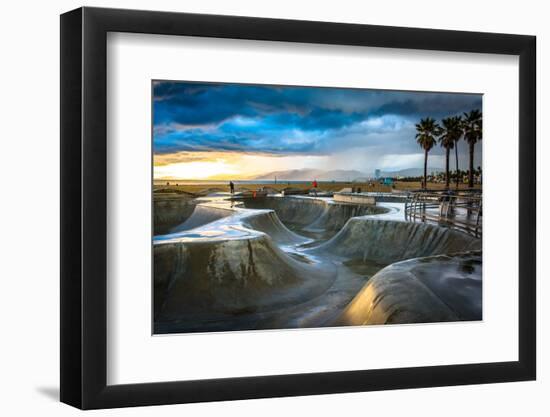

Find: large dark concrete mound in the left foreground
154;234;336;321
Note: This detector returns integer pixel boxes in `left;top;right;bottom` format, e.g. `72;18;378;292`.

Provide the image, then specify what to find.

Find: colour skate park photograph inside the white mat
151;80;483;334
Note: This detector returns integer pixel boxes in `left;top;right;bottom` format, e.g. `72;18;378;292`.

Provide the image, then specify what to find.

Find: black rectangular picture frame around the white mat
60;7;536;409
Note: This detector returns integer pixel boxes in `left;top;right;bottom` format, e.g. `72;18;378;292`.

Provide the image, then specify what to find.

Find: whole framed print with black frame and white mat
61;8;536;409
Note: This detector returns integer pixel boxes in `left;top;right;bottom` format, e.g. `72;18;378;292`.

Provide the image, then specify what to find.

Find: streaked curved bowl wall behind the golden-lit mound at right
308;216;481;264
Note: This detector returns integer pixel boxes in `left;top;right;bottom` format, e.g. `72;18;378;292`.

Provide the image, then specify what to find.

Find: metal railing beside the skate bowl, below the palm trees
405;191;483;238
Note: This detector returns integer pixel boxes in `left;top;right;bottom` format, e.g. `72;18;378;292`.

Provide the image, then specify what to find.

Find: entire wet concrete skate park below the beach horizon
153;191;482;334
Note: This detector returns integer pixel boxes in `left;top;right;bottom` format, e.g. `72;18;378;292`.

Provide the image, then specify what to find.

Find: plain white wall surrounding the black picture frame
0;0;550;417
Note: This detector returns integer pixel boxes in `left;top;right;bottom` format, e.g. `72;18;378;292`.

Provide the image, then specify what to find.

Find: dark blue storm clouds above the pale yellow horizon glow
153;82;481;158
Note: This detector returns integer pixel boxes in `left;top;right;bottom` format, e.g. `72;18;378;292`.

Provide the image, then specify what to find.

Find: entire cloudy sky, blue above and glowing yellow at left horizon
153;81;481;179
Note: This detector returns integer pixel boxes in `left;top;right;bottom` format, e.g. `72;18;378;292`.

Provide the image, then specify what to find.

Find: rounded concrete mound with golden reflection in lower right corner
329;251;482;326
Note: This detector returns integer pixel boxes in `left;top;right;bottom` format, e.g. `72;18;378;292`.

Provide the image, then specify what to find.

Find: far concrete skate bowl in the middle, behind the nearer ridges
242;197;388;241
